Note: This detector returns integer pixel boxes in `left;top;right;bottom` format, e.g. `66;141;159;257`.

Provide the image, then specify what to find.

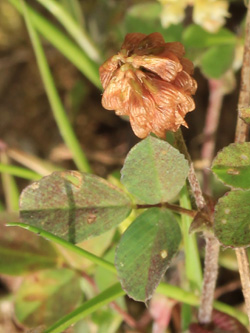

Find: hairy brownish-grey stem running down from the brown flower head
176;131;220;324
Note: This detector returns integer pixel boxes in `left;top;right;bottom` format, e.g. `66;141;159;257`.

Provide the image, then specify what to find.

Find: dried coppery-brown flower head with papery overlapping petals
100;32;197;139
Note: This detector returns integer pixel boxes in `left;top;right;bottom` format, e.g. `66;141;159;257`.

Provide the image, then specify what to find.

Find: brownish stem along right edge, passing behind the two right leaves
234;1;250;322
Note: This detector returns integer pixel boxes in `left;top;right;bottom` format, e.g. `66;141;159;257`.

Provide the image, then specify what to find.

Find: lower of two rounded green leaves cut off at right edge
214;190;250;247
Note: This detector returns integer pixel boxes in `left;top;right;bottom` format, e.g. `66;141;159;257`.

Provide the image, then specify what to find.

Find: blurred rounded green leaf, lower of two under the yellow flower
201;45;235;79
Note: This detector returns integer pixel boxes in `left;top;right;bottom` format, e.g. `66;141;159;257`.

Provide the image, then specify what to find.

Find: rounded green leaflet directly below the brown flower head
121;136;189;204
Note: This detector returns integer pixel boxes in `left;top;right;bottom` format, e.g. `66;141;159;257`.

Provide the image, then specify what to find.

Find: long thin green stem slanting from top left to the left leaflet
21;0;91;172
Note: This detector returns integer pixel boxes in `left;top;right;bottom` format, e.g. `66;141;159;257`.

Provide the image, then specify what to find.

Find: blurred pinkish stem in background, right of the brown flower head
201;79;224;194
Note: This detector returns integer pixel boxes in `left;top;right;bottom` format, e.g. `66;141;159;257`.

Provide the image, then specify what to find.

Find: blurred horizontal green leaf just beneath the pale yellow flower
183;24;236;48
